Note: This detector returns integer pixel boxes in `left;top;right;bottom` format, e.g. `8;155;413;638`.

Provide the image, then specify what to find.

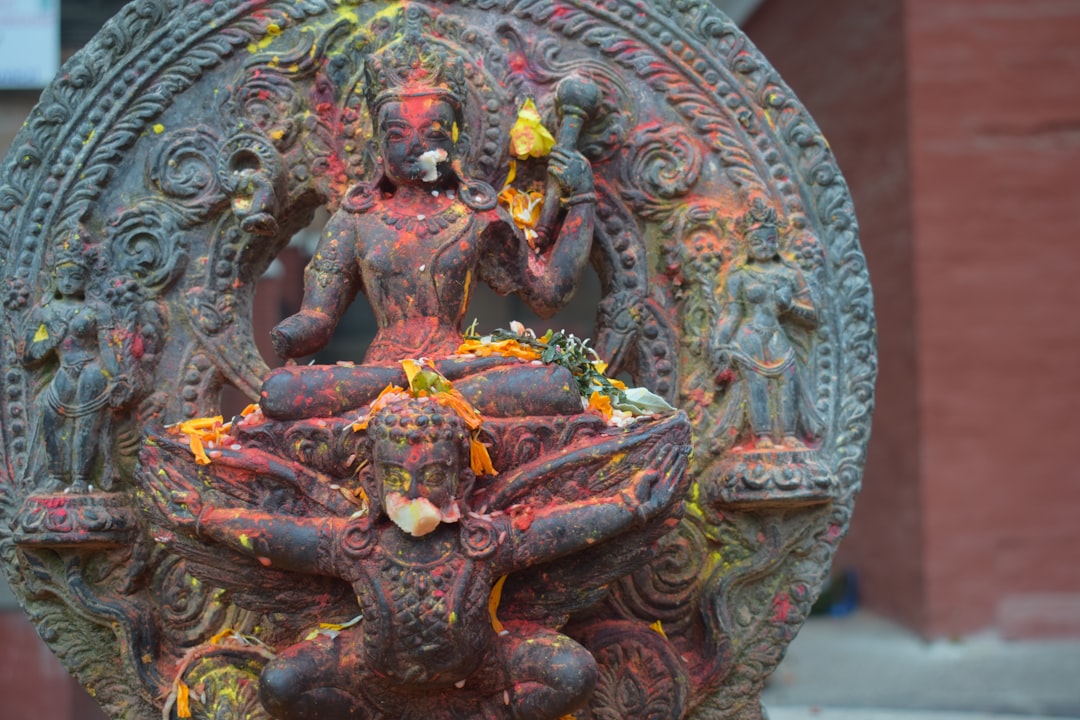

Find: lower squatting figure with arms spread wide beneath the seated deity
159;397;686;720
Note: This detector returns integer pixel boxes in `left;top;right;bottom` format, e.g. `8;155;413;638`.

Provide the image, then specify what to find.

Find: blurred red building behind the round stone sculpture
0;0;1080;720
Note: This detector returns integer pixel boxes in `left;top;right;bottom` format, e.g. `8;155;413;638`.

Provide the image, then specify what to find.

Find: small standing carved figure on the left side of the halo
23;228;131;492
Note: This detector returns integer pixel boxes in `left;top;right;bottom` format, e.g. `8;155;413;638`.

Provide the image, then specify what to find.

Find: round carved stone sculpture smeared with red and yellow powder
0;0;875;720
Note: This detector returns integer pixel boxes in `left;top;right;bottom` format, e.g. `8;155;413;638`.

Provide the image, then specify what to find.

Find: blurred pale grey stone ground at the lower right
762;612;1080;720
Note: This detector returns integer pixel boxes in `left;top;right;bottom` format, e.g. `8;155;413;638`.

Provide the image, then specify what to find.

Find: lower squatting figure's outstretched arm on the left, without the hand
195;506;348;575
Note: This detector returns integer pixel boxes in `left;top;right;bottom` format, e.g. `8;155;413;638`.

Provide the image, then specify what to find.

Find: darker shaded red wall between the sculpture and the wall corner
746;0;924;626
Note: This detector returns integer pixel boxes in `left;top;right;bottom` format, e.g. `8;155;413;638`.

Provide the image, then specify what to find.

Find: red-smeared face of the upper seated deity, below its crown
379;95;455;186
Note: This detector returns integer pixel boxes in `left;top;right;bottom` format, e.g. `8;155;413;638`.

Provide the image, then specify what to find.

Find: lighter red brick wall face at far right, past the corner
907;0;1080;635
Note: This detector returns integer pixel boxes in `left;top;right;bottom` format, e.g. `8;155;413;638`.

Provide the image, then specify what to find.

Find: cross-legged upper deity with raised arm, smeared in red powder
261;37;596;419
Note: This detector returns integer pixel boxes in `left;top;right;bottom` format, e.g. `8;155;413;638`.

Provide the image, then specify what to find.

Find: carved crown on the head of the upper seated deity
365;31;467;116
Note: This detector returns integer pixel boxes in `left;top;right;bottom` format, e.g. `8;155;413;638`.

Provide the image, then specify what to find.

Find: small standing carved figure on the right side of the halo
711;199;821;449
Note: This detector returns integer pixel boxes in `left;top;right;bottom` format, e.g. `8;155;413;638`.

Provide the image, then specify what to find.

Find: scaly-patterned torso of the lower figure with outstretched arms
356;543;491;683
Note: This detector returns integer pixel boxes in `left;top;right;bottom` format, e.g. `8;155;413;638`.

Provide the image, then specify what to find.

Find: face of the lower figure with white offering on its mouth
373;439;461;536
